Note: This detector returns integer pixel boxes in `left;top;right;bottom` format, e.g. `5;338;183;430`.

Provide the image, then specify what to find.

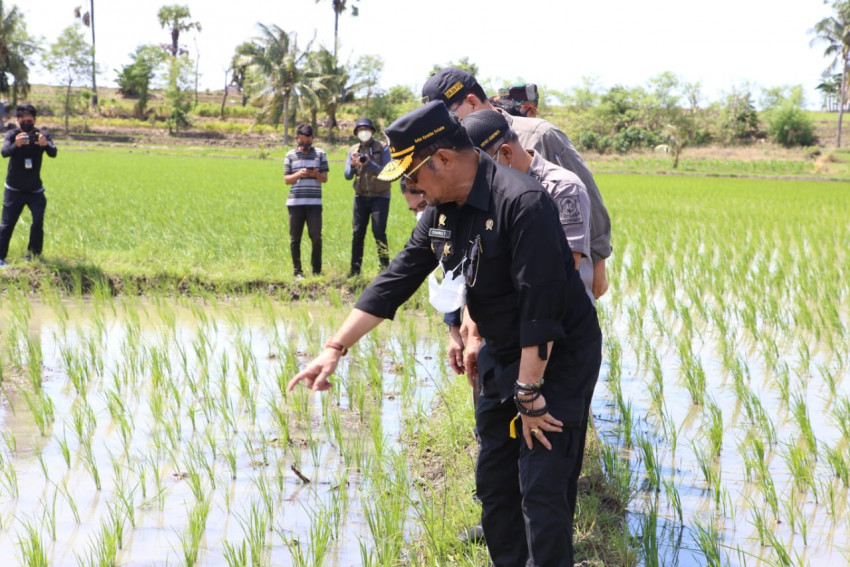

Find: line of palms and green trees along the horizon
0;0;850;153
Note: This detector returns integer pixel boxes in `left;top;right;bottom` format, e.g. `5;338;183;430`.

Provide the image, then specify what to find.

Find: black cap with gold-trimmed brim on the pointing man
378;100;460;181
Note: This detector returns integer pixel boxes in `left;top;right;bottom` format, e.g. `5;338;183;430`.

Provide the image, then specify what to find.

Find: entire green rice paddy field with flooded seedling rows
0;147;850;566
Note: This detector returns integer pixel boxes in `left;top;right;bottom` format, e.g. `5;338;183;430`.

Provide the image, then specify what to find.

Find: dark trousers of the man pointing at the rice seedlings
475;340;601;567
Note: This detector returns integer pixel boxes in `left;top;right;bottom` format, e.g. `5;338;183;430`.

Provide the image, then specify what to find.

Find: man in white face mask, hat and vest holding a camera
345;118;392;277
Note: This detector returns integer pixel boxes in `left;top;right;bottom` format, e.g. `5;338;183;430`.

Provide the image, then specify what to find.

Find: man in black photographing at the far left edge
0;104;56;268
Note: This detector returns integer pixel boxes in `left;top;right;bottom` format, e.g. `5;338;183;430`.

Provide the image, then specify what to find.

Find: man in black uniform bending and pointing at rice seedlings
288;101;601;567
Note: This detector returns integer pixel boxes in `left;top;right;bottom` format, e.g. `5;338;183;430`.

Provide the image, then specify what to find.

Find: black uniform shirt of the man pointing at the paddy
356;152;595;363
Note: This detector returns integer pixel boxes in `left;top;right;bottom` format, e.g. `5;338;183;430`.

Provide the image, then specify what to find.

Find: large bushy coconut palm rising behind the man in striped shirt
239;24;312;145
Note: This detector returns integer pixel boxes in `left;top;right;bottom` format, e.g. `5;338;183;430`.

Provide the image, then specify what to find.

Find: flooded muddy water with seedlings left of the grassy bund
0;299;445;566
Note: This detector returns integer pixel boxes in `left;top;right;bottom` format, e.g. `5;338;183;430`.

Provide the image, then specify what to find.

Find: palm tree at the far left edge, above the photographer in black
0;0;37;106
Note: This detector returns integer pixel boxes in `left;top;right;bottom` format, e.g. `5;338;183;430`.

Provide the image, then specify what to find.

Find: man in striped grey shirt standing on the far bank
283;124;329;278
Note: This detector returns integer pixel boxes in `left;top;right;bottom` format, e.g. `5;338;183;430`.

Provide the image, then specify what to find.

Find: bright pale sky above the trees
19;0;831;108
